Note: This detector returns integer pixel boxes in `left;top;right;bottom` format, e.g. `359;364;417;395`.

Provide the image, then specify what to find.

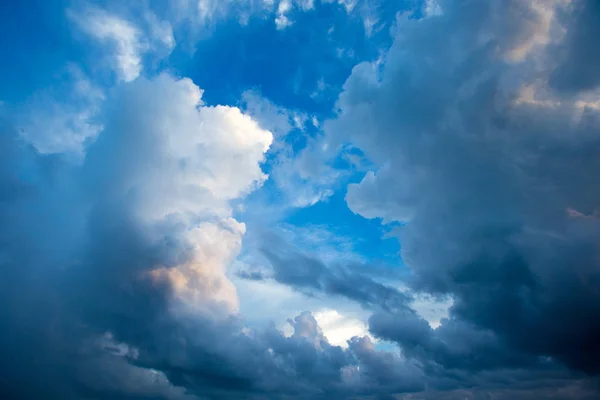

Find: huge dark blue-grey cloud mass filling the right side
325;1;600;390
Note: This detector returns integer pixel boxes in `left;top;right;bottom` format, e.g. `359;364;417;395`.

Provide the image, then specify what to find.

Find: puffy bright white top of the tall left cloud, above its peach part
95;74;272;218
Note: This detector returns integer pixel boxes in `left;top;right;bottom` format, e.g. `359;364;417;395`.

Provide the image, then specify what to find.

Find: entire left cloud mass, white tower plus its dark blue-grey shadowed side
0;75;272;398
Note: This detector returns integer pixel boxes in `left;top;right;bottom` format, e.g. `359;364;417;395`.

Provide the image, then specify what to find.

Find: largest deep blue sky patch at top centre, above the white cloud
170;2;402;112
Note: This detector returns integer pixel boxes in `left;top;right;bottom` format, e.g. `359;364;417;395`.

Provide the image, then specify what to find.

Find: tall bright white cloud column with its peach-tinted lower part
86;74;272;315
